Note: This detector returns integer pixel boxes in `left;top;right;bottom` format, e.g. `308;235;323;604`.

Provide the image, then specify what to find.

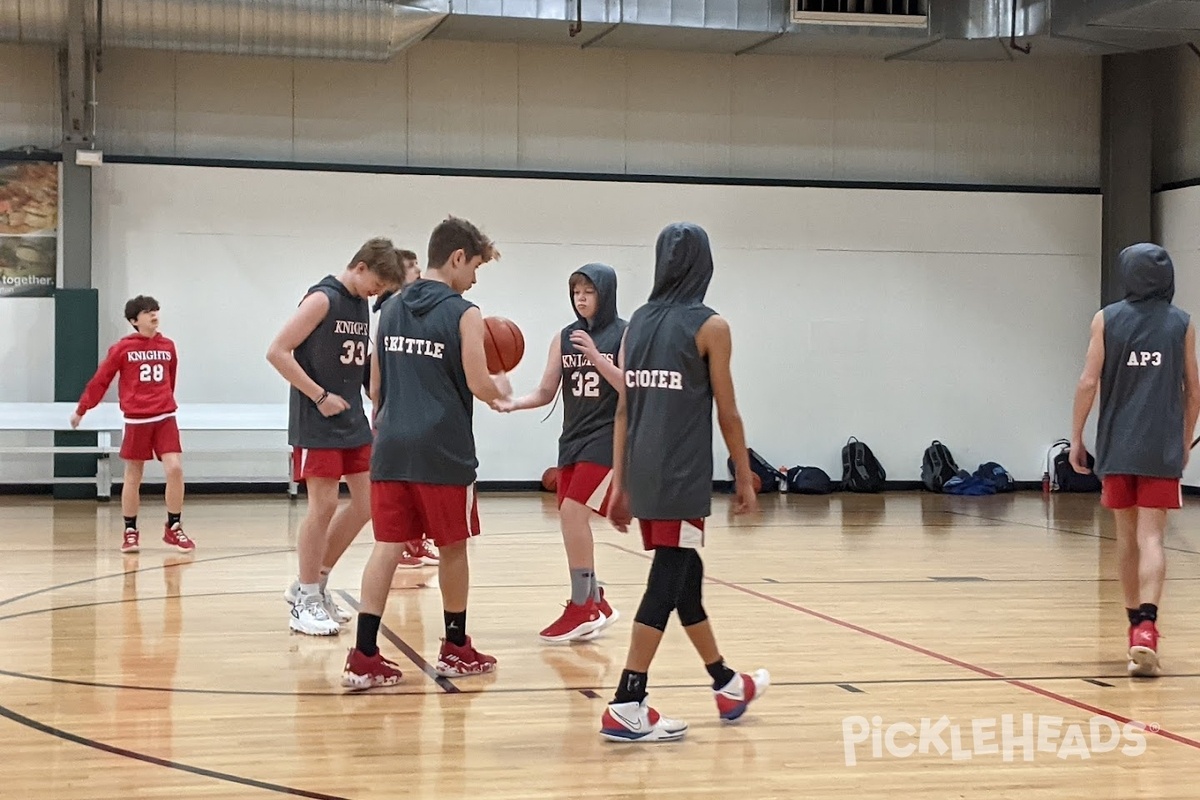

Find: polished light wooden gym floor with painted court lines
0;493;1200;800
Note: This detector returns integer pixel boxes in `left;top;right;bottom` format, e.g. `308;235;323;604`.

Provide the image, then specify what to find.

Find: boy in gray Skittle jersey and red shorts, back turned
342;217;511;688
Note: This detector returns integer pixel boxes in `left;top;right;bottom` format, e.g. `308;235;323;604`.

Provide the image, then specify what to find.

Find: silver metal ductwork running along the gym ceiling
0;0;1200;61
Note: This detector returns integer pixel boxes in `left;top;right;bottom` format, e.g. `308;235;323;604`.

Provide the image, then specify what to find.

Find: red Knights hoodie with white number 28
76;333;179;422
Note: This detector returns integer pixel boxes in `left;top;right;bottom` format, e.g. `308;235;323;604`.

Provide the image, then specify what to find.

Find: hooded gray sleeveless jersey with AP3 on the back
1096;245;1190;477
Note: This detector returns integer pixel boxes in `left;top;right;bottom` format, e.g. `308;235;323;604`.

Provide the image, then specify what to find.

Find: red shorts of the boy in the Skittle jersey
371;481;479;547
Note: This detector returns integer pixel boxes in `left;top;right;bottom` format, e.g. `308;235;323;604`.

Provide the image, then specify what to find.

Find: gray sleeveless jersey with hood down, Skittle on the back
371;279;479;486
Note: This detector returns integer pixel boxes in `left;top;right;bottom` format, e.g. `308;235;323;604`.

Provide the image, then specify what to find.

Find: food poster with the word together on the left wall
0;161;59;297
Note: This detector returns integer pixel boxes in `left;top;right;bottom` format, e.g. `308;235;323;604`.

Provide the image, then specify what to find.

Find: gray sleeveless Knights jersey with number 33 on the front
288;275;371;450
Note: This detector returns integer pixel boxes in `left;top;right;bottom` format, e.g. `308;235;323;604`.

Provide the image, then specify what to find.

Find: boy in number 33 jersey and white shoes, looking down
266;239;401;636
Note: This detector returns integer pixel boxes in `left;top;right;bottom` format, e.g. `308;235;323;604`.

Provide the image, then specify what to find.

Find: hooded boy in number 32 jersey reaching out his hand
493;264;626;643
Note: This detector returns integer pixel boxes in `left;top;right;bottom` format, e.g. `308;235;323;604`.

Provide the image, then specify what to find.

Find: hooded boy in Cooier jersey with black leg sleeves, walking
600;223;770;741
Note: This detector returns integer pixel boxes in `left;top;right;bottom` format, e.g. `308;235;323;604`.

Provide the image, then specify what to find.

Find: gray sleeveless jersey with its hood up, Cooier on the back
623;223;716;519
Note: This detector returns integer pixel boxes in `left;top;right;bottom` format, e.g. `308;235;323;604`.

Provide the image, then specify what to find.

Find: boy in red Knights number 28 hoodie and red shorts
71;295;196;553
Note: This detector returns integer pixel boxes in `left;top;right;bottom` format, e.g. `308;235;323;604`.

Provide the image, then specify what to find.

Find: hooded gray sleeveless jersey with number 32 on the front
558;264;626;467
